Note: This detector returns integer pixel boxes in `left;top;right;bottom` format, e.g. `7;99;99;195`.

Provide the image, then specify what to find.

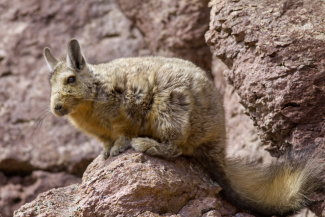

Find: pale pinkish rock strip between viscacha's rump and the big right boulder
212;57;271;162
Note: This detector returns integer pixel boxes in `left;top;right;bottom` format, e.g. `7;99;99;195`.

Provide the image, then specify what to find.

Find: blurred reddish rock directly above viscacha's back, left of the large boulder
116;0;211;71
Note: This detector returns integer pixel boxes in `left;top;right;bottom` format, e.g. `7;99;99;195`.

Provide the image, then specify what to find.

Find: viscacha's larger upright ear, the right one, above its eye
67;39;86;71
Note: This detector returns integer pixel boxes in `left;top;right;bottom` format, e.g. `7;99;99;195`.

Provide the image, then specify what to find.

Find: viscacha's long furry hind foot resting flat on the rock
131;138;182;158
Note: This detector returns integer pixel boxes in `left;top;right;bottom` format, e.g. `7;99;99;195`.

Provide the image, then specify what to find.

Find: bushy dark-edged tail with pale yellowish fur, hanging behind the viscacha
196;148;324;216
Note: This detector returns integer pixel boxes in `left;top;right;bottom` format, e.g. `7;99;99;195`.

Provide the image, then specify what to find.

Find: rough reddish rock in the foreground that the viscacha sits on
14;150;251;217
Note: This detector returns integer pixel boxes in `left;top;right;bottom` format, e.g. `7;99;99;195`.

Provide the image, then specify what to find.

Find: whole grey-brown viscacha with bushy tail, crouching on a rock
44;39;322;216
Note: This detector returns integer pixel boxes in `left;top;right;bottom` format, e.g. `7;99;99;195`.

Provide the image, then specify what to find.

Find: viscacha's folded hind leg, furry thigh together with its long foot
131;86;191;158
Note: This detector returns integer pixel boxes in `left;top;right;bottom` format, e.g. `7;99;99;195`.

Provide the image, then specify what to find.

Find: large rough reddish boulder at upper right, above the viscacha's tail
206;0;325;155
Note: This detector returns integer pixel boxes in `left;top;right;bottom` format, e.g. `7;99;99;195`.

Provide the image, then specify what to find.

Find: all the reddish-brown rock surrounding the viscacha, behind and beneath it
0;0;325;217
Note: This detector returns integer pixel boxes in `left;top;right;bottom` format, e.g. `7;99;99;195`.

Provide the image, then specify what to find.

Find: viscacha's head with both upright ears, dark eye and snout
43;39;95;117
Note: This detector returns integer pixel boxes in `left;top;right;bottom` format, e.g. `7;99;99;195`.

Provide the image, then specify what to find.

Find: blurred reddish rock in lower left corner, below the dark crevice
0;171;81;217
